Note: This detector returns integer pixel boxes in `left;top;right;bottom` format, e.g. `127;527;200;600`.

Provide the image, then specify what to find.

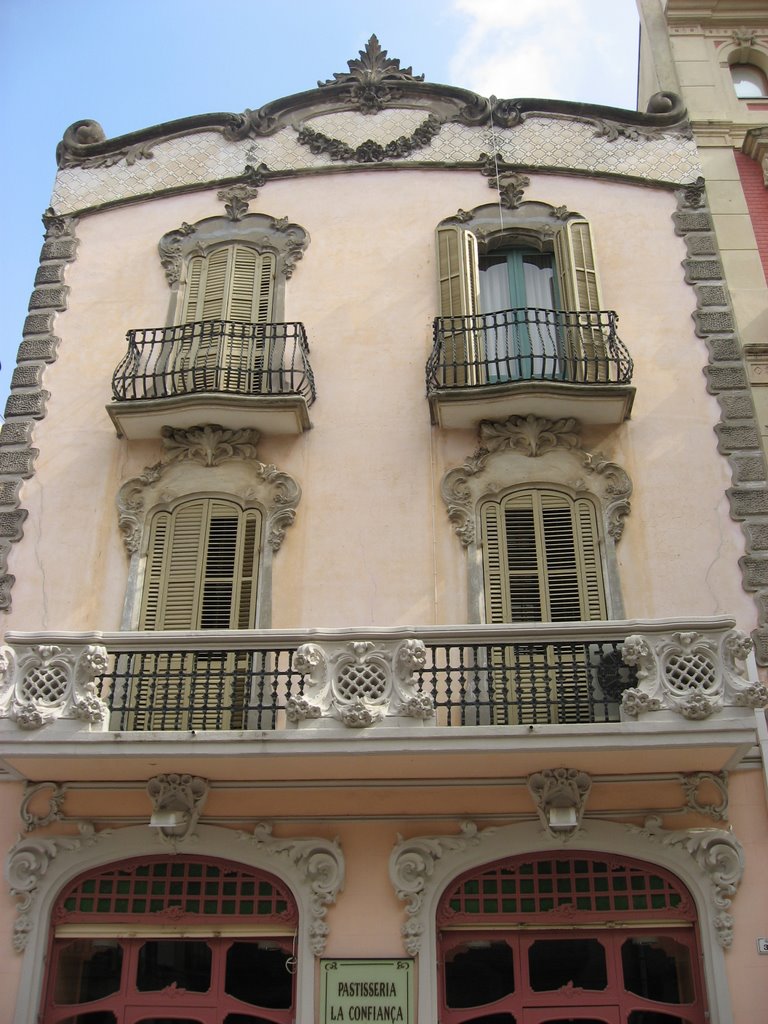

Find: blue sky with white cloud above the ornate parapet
0;0;638;411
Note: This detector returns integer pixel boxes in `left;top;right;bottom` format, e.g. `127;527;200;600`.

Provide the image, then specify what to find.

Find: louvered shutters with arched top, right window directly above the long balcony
480;490;605;623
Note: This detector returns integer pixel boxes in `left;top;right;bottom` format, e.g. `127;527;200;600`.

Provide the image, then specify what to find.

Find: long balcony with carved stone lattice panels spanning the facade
0;618;768;777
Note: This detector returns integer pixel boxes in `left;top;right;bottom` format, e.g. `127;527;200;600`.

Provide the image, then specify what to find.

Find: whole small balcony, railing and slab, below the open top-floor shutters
426;308;635;429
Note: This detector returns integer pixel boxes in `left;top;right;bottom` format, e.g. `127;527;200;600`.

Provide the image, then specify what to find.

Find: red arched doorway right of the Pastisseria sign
437;852;706;1024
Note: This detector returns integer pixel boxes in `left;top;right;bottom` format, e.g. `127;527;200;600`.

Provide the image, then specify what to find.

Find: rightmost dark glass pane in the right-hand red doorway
622;935;693;1002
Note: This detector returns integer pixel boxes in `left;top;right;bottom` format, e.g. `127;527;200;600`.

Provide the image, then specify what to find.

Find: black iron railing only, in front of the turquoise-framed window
427;308;633;394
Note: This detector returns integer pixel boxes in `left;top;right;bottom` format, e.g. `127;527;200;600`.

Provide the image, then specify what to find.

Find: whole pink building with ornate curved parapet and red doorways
0;37;768;1024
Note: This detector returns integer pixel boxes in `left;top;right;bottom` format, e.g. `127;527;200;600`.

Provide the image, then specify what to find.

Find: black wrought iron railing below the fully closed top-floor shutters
112;321;315;404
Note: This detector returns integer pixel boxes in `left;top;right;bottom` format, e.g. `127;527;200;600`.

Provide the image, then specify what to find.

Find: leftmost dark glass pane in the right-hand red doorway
445;942;515;1007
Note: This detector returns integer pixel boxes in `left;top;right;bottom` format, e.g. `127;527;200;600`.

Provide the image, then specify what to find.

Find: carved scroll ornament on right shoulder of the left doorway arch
238;821;344;956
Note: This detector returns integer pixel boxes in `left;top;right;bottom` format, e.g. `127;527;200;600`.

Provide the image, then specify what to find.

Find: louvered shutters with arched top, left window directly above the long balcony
139;499;261;630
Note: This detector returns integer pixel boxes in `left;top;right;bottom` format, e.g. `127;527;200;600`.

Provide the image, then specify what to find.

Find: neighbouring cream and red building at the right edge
638;0;768;664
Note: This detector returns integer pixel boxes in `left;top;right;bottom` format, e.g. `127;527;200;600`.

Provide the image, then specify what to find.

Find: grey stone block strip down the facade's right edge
673;184;768;666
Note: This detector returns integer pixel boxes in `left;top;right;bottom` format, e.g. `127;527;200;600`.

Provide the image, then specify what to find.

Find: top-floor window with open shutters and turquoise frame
437;216;607;386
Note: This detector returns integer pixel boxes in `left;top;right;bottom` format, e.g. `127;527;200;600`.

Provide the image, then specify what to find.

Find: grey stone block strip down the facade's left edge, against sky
0;210;78;611
